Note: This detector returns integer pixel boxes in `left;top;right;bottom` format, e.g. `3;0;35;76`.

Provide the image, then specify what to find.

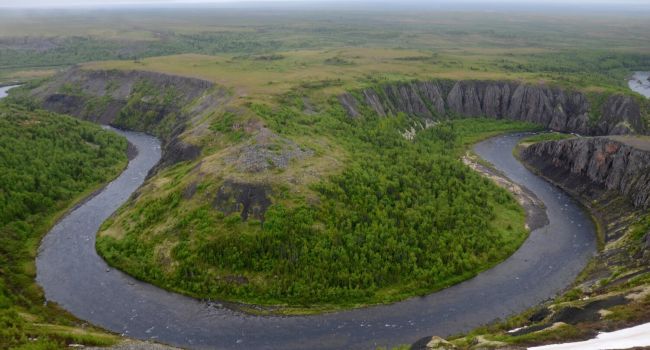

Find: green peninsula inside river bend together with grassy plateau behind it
62;10;647;313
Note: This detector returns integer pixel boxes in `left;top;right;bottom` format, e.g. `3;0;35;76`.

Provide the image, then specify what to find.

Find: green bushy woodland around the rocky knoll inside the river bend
97;91;534;312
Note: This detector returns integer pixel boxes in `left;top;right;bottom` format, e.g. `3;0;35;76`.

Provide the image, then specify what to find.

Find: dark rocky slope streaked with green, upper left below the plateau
31;68;214;133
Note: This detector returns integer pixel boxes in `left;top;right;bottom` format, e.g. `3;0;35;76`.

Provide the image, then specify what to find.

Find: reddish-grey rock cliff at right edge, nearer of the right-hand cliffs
522;137;650;209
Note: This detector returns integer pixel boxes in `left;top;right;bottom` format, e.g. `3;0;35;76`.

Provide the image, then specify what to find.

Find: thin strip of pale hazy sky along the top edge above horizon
0;0;650;7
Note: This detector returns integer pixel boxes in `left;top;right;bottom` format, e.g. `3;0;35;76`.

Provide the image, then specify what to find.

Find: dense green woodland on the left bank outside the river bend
0;103;126;349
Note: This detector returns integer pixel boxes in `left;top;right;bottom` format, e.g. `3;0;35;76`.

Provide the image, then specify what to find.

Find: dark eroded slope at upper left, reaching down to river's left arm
29;68;220;166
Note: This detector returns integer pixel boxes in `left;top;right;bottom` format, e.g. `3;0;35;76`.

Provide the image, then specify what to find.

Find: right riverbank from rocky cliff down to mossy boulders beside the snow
418;136;650;348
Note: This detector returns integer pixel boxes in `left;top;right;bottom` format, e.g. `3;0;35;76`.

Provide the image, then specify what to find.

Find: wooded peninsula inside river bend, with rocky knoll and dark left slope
27;61;534;312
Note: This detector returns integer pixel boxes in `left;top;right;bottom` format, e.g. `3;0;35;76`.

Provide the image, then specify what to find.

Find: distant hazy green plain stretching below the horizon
0;8;650;90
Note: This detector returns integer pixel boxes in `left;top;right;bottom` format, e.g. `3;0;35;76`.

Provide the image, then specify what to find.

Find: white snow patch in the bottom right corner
528;323;650;350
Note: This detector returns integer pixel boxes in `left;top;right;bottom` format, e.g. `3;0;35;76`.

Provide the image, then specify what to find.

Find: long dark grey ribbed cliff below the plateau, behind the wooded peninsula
339;80;644;135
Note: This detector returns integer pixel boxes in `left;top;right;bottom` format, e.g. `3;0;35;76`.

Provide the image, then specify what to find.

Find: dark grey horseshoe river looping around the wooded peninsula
31;127;596;350
